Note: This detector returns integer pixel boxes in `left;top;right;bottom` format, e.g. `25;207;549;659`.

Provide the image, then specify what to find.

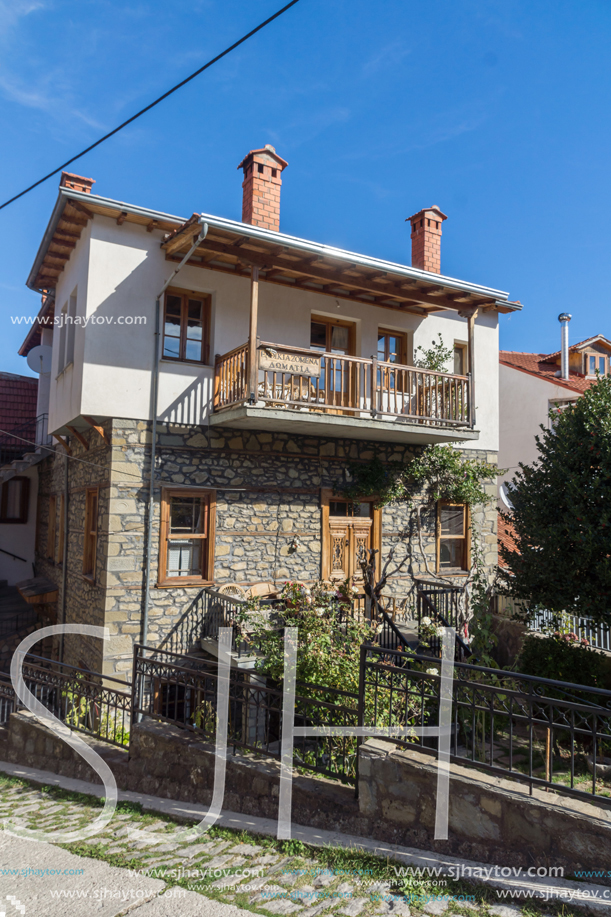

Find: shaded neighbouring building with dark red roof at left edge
0;372;41;586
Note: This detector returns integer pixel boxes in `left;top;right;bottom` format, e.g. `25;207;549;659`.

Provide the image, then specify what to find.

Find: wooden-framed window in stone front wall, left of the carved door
158;487;216;586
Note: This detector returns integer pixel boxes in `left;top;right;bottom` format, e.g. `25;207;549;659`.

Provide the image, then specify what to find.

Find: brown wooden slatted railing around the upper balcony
214;343;472;427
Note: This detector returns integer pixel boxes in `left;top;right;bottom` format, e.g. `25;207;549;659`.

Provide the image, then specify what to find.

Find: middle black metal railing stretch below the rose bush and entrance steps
132;645;358;783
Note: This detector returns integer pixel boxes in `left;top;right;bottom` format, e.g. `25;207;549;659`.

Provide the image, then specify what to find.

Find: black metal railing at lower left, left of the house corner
0;656;132;747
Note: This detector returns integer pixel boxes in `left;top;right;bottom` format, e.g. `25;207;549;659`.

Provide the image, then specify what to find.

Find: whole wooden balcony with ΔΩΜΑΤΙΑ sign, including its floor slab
211;343;478;443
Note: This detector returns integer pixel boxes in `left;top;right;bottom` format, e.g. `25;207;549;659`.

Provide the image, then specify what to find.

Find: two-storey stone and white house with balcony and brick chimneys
20;146;521;672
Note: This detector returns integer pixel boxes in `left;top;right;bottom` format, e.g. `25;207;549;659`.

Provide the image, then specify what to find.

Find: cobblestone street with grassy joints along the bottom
0;778;602;917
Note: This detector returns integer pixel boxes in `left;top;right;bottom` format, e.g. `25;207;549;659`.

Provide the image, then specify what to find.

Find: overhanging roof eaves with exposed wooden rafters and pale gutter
28;188;522;315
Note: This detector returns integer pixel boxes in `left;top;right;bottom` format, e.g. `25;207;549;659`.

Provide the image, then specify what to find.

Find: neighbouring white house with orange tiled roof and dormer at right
499;316;611;498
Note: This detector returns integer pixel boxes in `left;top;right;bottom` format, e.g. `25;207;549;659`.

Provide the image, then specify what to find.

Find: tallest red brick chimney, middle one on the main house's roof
238;143;288;232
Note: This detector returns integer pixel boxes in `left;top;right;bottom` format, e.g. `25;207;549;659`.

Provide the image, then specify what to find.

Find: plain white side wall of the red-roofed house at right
499;363;579;483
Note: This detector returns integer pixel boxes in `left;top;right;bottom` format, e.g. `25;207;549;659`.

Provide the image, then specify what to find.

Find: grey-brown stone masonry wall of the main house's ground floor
37;419;497;676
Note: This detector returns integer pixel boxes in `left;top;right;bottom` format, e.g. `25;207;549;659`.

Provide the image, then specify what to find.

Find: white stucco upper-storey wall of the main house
44;215;498;451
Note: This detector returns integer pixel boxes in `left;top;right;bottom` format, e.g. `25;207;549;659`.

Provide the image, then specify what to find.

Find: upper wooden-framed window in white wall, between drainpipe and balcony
163;290;210;363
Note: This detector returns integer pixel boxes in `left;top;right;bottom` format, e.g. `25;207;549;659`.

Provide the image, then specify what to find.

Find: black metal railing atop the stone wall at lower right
359;646;611;804
